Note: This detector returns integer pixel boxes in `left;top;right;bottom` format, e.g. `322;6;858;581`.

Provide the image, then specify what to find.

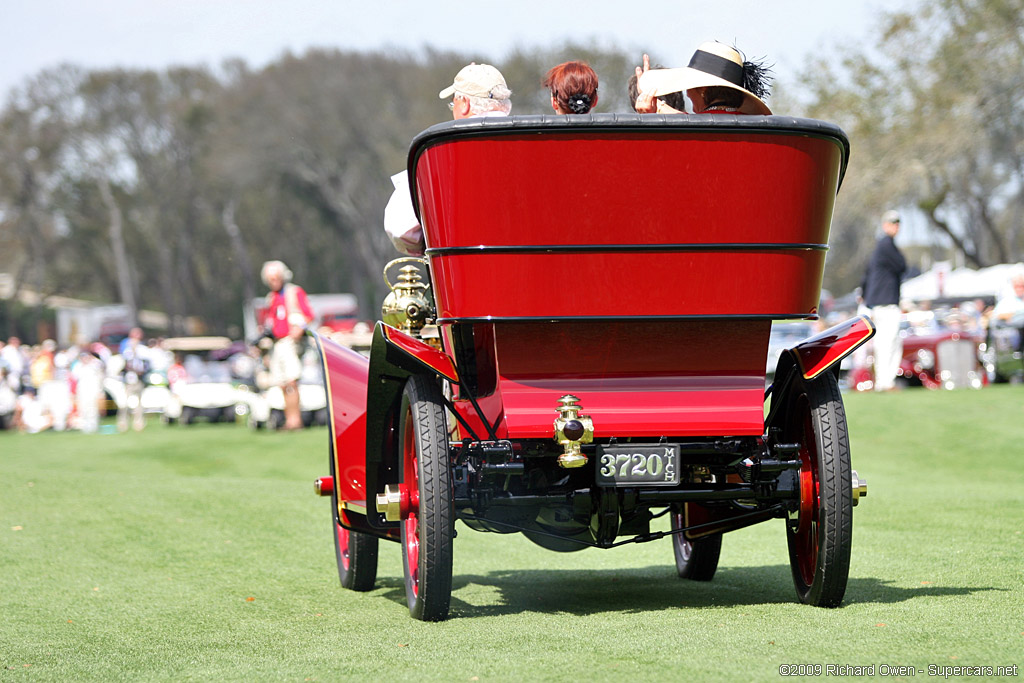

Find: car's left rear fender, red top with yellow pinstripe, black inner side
365;322;459;529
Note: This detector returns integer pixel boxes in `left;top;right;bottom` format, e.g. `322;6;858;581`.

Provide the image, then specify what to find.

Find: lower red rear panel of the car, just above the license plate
456;321;770;439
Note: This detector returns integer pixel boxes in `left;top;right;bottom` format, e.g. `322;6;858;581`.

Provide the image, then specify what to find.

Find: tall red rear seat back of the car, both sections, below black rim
415;130;841;317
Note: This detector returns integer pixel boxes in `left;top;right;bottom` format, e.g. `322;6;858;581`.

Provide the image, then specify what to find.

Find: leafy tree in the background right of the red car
805;0;1024;286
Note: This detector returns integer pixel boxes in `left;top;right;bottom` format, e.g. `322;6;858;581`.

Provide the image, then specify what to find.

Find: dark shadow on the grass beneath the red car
378;564;1005;618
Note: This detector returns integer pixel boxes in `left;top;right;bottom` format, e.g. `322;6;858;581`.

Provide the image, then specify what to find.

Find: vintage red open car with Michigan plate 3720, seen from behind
316;115;873;621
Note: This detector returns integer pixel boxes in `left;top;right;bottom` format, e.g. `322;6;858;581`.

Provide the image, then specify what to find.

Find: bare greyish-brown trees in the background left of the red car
0;45;632;337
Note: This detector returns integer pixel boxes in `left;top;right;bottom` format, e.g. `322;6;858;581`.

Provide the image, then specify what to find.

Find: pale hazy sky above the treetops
0;0;897;98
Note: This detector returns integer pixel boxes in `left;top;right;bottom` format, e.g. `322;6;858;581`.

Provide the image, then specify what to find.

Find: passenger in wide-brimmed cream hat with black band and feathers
634;42;771;115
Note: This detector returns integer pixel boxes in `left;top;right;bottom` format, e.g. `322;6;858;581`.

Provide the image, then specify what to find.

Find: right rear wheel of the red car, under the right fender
783;373;853;607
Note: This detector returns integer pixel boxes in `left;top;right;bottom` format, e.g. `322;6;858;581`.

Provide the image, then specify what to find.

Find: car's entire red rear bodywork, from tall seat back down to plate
411;121;843;439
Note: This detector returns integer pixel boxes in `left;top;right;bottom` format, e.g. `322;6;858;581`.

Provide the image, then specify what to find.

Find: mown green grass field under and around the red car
0;386;1024;681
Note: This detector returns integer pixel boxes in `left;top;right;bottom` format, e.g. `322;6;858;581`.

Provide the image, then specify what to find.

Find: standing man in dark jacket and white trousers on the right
861;211;906;391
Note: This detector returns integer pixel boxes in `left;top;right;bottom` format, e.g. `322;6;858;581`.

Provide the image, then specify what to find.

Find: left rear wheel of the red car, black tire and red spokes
398;375;455;622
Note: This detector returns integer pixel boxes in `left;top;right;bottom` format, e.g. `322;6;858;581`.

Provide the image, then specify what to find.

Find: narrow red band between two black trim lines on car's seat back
431;250;825;319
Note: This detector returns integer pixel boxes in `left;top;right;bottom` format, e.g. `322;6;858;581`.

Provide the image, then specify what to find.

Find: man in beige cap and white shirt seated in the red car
384;63;512;256
